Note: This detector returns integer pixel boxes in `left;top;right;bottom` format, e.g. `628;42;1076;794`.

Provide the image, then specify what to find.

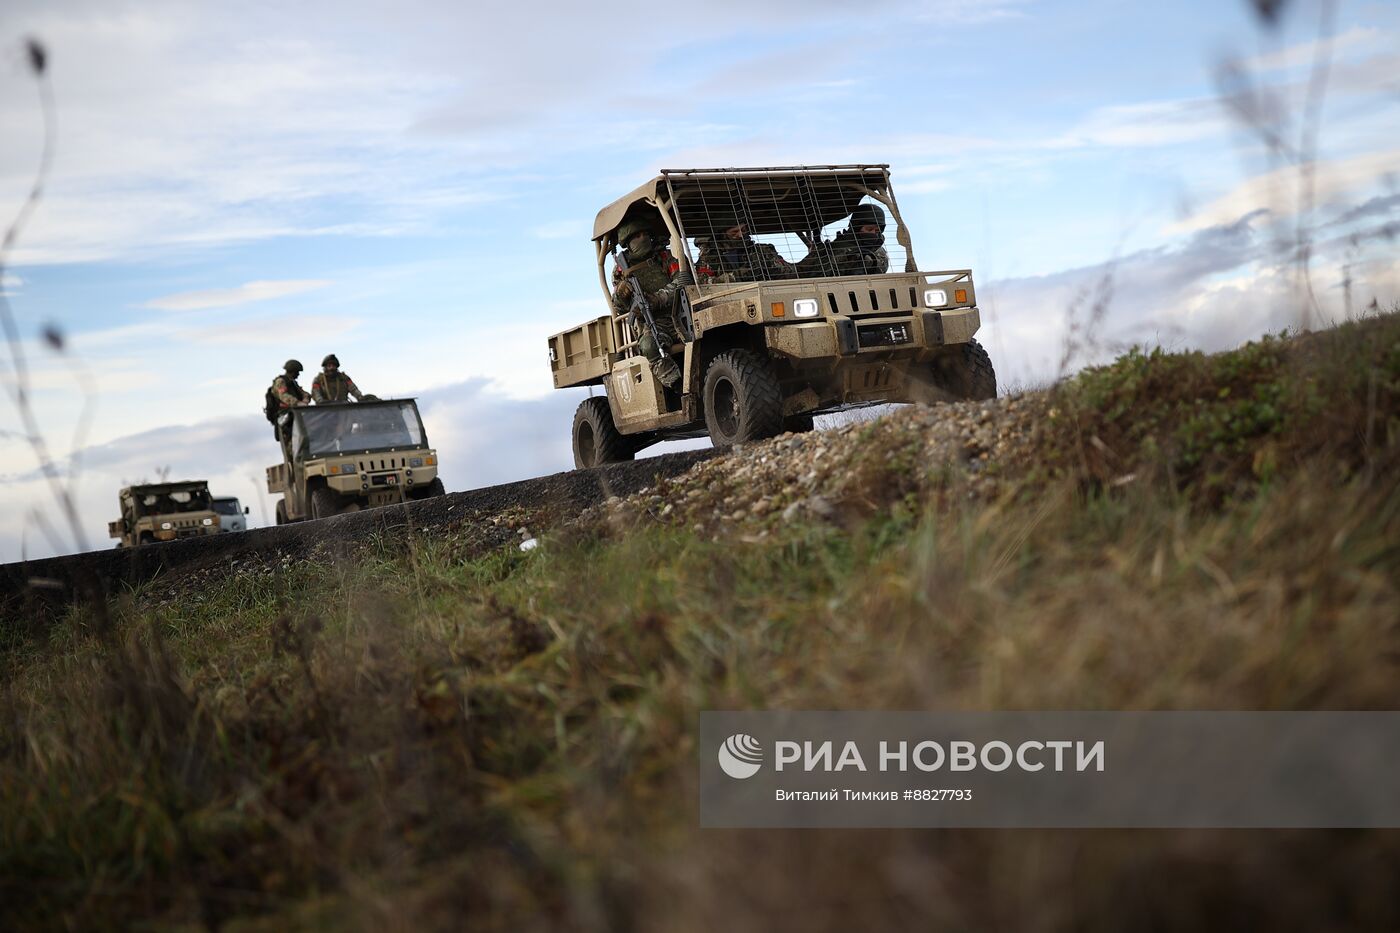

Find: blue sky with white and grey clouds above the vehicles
0;0;1400;551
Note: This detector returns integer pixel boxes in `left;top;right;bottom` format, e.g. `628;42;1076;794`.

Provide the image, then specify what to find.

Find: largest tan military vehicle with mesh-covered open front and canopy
549;164;997;468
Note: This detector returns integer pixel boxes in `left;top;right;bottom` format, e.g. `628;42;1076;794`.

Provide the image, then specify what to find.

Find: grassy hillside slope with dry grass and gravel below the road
0;314;1400;930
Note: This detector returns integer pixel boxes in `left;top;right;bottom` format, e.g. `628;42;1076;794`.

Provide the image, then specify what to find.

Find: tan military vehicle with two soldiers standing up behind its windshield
267;398;444;525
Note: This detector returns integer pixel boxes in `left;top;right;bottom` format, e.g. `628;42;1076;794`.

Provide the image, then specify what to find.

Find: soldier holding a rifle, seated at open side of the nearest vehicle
613;217;690;388
